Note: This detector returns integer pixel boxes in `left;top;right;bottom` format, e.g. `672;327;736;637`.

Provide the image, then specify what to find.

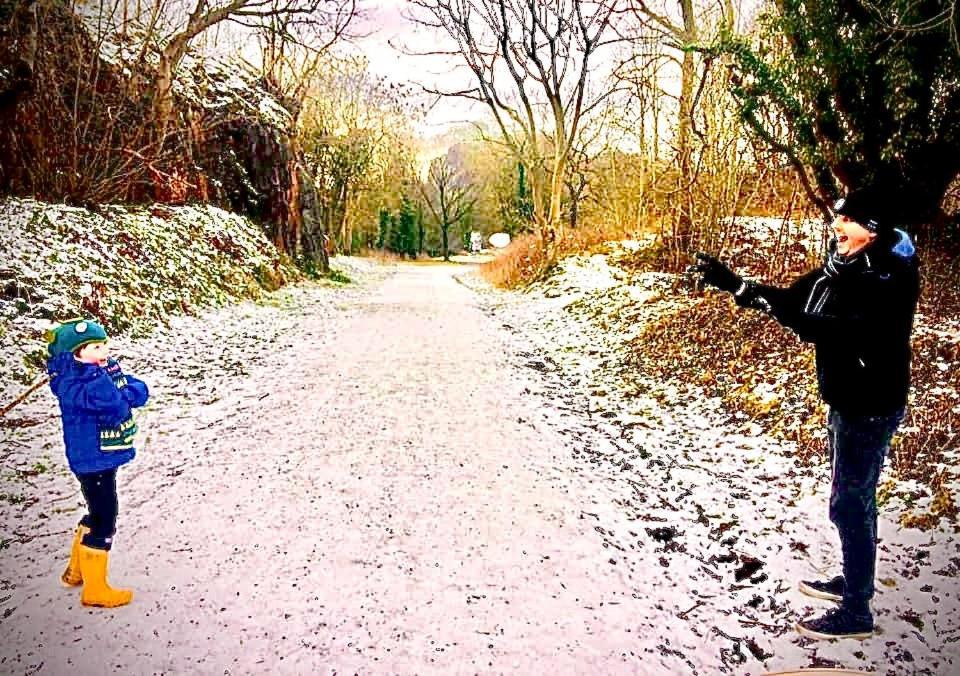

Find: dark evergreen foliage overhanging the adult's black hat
708;0;960;230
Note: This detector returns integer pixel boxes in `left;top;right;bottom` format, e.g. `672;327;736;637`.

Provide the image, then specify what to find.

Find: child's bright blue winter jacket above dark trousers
47;352;149;474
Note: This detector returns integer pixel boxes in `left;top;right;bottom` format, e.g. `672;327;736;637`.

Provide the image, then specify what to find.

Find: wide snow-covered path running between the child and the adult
0;266;668;674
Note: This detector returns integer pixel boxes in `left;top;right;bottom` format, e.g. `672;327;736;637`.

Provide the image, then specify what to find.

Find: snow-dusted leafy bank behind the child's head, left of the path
0;199;300;403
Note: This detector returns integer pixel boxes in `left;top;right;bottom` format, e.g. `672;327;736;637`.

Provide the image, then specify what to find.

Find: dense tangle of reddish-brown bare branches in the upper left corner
0;0;178;202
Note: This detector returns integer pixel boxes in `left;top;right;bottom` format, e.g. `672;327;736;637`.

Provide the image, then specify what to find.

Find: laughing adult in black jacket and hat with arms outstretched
692;188;920;639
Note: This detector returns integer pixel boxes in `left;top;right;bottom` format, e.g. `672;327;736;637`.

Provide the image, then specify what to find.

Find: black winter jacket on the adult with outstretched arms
736;230;920;416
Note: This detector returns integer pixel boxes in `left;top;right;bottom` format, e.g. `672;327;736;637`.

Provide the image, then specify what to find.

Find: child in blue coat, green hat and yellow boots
46;319;148;608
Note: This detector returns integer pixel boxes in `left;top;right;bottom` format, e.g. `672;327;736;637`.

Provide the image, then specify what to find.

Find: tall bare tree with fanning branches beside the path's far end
411;0;621;265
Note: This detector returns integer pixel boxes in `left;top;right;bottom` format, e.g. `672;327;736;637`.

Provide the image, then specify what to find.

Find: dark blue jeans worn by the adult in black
827;409;904;616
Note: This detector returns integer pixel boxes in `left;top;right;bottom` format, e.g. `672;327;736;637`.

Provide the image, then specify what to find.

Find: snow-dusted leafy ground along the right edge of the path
462;231;960;674
